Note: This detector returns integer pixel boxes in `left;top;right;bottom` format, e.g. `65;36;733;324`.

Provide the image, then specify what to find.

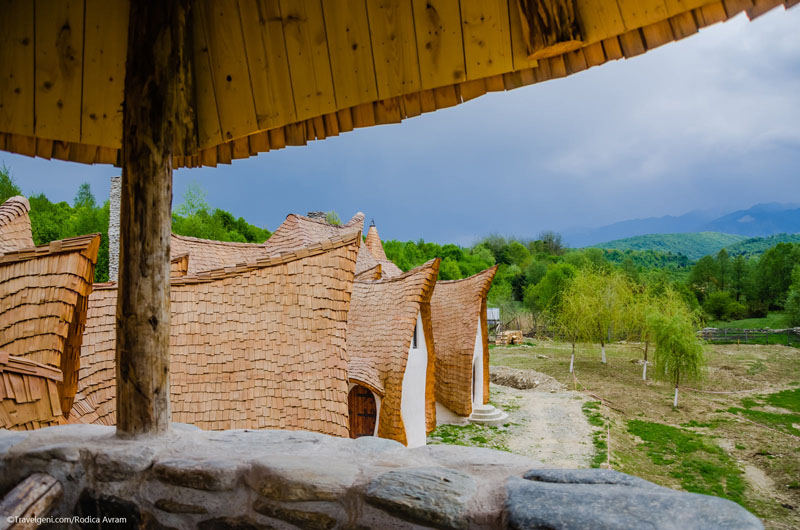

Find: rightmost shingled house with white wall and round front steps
431;266;502;423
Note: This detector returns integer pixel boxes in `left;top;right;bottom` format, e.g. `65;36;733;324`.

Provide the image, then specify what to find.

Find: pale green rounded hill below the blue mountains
595;232;747;260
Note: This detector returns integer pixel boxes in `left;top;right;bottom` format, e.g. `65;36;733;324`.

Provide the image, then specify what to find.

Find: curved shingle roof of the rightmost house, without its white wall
431;266;497;416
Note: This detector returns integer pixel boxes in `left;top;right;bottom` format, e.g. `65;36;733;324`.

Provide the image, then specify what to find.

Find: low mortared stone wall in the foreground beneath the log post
0;424;763;530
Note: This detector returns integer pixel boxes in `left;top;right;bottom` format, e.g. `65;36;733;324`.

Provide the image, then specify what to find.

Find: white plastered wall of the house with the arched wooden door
400;313;428;447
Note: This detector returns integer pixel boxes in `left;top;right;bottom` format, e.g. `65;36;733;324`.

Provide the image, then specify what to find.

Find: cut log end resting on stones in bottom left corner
0;473;64;529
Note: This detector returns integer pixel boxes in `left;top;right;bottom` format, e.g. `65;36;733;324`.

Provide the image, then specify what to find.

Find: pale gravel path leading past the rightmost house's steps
491;384;595;468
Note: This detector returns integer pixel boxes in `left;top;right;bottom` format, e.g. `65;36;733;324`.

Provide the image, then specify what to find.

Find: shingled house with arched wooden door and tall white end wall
347;259;439;447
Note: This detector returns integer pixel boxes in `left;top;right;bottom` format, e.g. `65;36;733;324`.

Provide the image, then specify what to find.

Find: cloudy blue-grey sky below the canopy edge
0;8;800;244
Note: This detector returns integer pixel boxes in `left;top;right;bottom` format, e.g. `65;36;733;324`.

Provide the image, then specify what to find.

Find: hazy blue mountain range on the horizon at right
562;202;800;248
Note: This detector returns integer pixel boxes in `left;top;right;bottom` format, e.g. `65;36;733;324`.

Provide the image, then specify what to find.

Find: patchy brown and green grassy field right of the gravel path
491;341;800;529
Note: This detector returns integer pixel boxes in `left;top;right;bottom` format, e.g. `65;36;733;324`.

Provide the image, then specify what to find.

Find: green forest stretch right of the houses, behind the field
384;232;800;326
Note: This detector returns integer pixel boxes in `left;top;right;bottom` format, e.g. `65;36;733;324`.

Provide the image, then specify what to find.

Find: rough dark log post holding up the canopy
116;0;196;437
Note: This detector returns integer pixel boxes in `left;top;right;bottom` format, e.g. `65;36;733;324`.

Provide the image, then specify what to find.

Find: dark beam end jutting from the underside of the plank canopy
517;0;583;59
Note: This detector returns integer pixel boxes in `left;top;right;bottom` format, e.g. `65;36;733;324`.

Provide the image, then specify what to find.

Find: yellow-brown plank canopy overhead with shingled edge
0;0;797;167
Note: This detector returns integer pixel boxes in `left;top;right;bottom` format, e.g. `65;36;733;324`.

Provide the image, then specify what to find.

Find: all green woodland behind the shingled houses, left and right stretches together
0;166;800;326
